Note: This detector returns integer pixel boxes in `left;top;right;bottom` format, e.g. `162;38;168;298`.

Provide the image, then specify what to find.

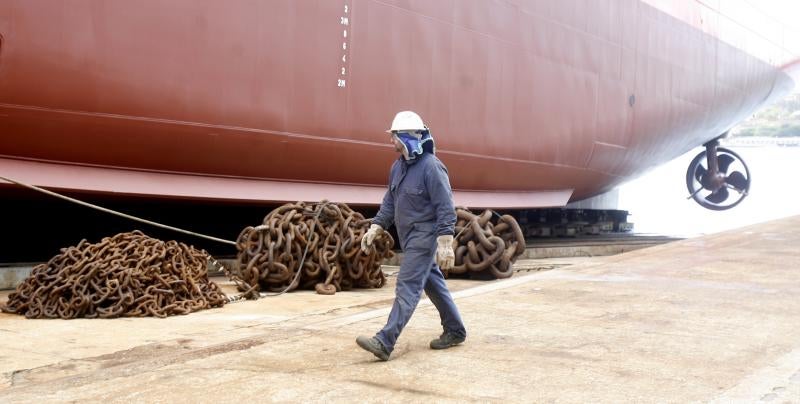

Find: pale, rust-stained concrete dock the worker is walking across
0;217;800;403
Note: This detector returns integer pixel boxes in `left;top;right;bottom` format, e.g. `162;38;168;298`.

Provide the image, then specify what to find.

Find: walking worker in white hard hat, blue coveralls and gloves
356;111;467;361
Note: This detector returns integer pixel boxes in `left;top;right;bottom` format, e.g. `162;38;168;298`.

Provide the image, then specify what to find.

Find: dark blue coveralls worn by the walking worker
372;153;467;353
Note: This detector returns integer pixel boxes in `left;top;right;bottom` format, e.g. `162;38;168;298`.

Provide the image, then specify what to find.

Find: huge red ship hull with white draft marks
0;0;794;208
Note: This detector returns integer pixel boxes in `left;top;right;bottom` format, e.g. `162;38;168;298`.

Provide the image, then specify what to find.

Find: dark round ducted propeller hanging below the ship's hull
686;145;750;210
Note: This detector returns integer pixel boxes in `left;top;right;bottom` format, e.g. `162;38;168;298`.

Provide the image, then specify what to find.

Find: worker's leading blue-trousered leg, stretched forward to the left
375;248;435;353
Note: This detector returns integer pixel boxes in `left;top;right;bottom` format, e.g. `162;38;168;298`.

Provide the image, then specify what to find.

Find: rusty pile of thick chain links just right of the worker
454;207;525;279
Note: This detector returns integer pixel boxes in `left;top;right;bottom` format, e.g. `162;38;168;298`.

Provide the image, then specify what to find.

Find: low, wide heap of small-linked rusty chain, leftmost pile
2;230;226;319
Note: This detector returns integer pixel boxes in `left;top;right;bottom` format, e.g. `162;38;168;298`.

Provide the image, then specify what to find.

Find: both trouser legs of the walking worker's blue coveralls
375;245;466;352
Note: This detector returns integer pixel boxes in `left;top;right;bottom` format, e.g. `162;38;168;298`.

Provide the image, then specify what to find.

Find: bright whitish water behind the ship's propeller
619;146;800;236
